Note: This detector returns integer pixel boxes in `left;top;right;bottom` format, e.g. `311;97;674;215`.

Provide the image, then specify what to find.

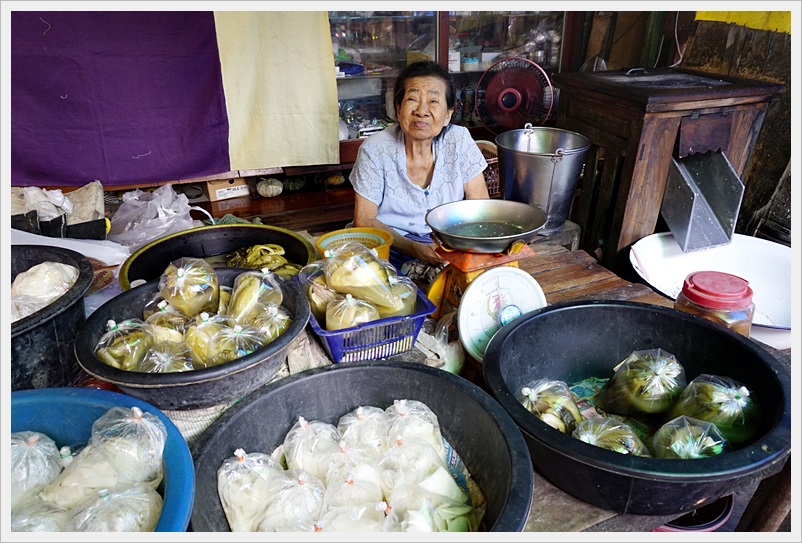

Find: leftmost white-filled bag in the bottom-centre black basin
217;449;286;532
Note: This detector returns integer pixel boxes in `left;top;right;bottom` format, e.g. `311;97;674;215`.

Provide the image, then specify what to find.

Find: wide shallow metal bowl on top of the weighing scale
426;198;546;253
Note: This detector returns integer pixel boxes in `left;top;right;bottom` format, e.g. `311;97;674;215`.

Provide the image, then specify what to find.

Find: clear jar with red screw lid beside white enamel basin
674;271;755;337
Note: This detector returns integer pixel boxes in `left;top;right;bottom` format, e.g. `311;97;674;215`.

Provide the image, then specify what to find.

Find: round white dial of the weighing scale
457;266;547;362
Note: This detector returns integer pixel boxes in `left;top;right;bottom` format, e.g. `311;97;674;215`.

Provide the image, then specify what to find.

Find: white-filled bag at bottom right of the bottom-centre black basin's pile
384;485;484;532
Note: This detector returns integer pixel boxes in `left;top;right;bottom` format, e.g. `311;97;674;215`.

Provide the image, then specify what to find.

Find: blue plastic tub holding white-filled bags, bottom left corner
11;388;195;532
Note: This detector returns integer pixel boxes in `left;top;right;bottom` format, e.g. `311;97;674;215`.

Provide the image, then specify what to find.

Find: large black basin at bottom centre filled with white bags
190;361;534;532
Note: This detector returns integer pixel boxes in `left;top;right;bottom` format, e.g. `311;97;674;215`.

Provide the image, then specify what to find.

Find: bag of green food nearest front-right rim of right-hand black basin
652;415;732;459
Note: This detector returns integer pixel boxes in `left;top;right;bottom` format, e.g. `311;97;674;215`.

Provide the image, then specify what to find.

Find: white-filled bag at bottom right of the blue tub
64;483;164;532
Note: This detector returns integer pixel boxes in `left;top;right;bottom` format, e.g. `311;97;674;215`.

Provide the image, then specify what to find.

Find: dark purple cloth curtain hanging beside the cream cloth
11;11;230;186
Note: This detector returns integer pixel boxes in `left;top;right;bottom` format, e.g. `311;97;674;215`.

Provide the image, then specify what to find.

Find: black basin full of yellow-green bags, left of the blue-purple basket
75;268;310;410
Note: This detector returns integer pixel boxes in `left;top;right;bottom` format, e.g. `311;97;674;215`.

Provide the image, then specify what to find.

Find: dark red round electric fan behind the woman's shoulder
475;57;553;134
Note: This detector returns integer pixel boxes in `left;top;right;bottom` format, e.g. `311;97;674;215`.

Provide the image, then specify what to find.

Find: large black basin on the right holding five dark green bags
483;301;791;515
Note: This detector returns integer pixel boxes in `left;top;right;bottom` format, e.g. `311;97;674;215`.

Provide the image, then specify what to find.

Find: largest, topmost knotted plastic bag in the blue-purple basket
325;241;402;310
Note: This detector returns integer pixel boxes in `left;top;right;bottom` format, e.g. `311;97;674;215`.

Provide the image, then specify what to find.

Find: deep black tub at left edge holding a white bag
11;245;92;390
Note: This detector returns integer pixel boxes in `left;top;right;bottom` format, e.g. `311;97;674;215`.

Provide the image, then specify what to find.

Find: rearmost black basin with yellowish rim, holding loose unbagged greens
118;224;317;290
